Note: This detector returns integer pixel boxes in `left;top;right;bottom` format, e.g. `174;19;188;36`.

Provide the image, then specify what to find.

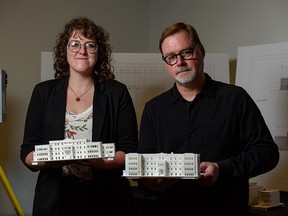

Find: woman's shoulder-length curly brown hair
53;17;115;82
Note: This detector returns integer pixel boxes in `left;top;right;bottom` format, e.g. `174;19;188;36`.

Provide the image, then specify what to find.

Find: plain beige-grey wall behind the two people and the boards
0;0;288;215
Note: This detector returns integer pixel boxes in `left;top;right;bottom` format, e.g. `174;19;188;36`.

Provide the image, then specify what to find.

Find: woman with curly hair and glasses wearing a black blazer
21;17;138;215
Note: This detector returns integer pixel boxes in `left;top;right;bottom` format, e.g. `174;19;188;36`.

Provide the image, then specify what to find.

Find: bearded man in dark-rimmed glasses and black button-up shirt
138;23;279;215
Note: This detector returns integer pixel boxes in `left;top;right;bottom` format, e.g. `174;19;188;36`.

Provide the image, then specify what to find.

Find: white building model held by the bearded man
123;153;200;179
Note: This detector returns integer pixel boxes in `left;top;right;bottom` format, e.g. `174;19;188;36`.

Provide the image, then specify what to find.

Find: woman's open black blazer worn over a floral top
20;78;138;214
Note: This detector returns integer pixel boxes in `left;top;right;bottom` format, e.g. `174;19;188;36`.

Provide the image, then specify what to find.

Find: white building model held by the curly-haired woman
32;139;115;165
